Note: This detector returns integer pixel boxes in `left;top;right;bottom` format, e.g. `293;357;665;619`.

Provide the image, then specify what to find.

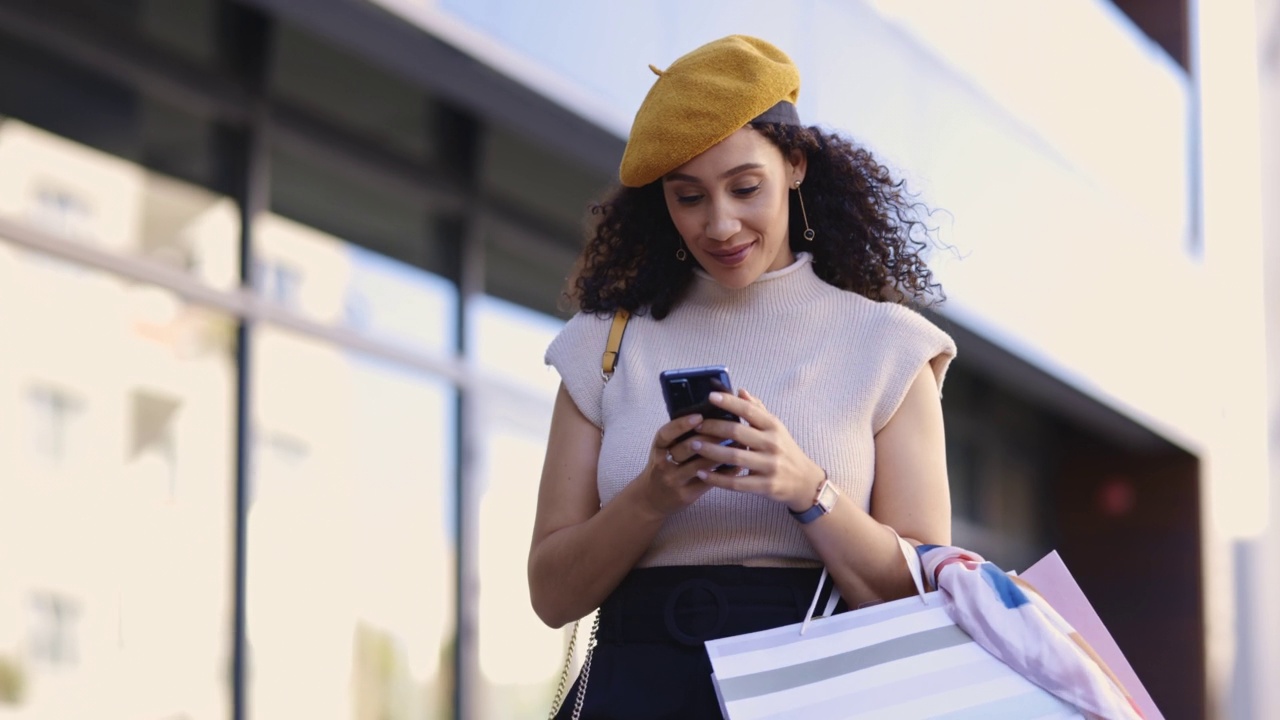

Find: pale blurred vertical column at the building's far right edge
1192;0;1280;720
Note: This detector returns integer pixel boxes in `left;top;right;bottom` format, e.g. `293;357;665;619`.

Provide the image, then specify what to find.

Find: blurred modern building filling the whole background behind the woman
0;0;1280;720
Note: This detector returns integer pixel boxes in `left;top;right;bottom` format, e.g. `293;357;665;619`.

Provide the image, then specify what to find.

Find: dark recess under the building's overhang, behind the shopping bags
933;316;1206;720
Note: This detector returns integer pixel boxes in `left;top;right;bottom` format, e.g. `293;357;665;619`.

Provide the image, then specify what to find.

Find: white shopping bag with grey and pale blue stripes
707;586;1083;720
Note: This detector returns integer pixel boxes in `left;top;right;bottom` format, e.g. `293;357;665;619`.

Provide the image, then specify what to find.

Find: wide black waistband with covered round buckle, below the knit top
596;565;844;646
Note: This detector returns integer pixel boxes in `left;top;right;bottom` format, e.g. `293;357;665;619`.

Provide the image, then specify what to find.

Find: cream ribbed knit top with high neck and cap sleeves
547;252;956;568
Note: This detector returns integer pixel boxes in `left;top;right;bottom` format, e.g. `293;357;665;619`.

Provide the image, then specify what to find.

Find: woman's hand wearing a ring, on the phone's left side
641;415;717;518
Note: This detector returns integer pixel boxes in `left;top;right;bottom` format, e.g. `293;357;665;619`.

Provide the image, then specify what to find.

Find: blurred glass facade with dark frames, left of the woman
0;0;605;720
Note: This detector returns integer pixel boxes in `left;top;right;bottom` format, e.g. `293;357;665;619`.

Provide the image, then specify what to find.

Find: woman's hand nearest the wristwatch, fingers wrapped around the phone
694;388;826;512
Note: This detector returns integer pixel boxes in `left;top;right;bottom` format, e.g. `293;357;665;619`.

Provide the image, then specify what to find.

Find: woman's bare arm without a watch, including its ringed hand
529;384;713;628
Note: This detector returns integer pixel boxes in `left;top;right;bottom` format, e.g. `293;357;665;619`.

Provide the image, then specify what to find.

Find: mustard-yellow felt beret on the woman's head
618;35;800;187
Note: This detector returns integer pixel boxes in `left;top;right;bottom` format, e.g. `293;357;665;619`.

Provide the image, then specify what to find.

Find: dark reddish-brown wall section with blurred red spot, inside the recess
1053;432;1206;720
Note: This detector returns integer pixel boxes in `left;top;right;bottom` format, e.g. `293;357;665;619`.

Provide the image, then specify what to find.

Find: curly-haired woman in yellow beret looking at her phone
529;36;955;719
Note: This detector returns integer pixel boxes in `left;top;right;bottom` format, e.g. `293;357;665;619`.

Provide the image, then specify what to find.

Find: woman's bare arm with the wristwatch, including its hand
696;366;951;607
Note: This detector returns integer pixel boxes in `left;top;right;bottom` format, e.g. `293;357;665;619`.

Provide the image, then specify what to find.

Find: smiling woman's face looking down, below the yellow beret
662;128;806;288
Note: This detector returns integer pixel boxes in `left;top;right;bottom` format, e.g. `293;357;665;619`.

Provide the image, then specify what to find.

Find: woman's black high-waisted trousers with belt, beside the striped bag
556;565;844;720
